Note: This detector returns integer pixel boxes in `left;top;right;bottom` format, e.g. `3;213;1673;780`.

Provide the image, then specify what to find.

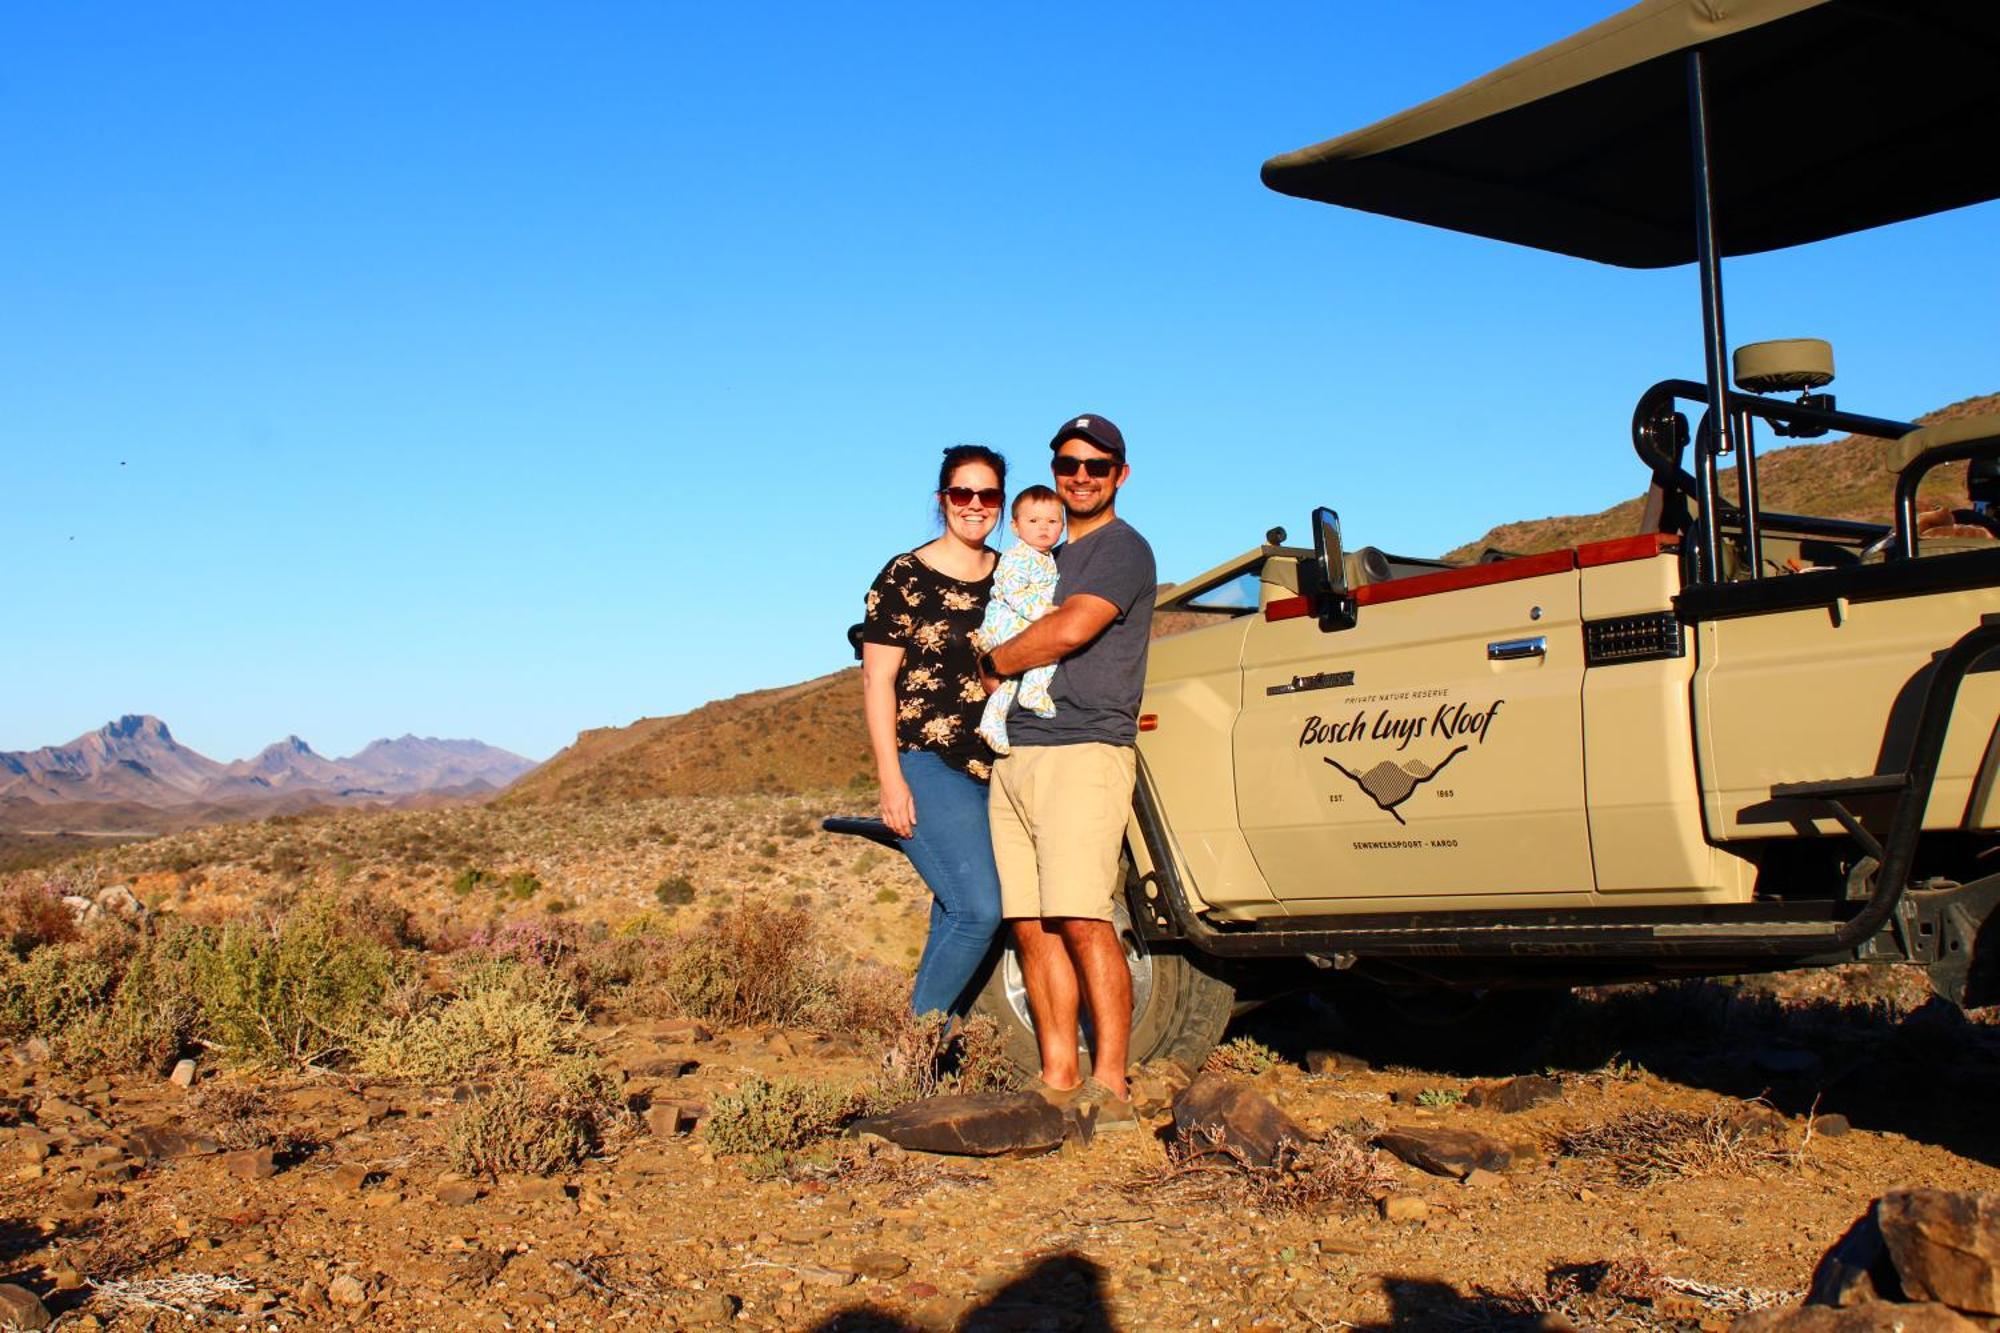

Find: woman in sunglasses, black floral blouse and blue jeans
862;444;1006;1015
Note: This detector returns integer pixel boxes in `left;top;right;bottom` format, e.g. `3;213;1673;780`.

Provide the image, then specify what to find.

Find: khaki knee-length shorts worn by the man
986;741;1138;921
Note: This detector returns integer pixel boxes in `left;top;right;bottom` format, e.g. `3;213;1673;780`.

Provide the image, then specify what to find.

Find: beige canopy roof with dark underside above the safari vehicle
1264;0;2000;268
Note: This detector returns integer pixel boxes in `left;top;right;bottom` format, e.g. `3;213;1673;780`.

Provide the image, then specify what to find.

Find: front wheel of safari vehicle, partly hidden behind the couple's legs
972;880;1236;1075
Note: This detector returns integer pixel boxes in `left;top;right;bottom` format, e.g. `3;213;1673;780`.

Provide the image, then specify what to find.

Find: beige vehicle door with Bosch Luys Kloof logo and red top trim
1232;532;1594;915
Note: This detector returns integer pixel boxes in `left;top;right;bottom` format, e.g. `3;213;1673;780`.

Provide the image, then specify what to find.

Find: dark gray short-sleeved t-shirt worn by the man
1006;518;1160;745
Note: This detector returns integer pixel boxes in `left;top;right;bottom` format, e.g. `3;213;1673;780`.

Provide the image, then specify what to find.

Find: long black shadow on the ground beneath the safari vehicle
1230;973;2000;1165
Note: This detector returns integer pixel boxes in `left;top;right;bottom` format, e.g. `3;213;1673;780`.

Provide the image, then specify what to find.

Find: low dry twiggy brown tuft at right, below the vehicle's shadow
1552;1107;1806;1189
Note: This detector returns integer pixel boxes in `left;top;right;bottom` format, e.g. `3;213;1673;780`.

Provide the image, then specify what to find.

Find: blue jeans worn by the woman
898;751;1000;1015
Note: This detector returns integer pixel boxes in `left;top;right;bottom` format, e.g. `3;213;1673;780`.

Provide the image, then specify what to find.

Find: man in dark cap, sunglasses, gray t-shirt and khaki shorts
982;414;1158;1129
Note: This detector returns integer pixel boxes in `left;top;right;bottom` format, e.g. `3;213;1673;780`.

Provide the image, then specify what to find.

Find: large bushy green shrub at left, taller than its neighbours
190;899;394;1065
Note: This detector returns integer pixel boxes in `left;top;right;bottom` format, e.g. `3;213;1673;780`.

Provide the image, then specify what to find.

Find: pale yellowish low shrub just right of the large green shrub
358;963;582;1083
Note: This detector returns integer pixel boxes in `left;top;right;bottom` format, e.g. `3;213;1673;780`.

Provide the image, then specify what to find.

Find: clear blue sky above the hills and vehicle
0;0;2000;759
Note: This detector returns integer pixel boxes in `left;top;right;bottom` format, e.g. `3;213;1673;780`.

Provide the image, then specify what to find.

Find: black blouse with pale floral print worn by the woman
862;552;994;783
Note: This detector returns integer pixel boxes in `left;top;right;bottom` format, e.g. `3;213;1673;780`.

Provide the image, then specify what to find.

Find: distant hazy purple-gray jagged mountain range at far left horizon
0;715;534;829
